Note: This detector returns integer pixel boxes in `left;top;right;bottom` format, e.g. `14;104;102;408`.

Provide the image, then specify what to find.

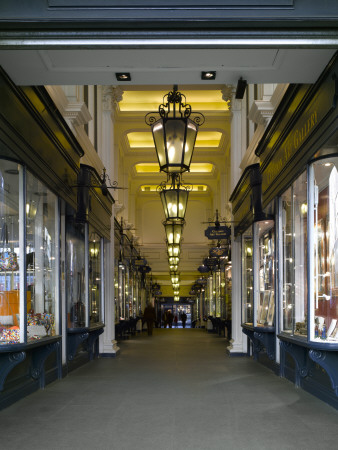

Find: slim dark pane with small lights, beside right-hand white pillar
242;227;254;325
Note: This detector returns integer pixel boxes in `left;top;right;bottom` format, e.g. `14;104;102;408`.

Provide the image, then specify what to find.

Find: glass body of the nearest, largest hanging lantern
151;118;198;173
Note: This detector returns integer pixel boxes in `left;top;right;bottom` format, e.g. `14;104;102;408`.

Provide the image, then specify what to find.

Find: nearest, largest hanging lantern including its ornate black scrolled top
145;85;205;173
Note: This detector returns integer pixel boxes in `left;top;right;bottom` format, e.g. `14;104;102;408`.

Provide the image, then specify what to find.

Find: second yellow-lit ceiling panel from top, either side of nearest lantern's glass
127;130;222;148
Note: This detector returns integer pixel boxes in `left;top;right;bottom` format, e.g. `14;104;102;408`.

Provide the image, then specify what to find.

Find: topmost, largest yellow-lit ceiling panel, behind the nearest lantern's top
119;88;229;112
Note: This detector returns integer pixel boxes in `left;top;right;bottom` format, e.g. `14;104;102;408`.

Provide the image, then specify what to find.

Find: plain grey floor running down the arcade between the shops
0;329;338;450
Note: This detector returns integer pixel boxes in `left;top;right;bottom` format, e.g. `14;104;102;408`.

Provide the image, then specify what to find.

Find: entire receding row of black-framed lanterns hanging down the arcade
145;85;205;299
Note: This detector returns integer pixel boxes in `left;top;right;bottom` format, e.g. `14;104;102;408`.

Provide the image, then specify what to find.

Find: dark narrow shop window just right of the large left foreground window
66;205;88;328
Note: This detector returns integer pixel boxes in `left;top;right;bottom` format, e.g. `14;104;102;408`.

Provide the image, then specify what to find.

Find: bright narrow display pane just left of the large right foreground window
253;220;275;327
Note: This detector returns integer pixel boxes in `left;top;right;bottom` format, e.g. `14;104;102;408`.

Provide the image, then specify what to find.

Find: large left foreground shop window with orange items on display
0;159;59;345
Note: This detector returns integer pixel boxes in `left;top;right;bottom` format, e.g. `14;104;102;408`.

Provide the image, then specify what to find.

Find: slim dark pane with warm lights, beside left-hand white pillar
89;226;102;324
